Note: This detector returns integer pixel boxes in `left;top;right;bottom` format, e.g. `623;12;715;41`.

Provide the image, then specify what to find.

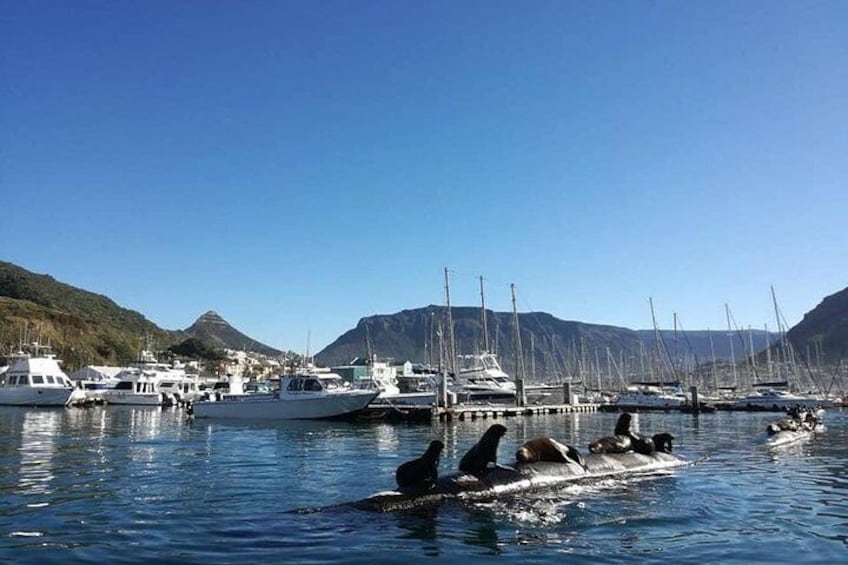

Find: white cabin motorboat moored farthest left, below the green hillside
0;345;76;406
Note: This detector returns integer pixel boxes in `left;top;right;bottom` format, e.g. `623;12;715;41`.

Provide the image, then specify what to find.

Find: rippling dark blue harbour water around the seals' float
0;407;848;563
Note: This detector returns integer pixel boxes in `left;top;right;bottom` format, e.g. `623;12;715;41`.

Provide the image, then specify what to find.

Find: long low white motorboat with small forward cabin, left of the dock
192;372;379;420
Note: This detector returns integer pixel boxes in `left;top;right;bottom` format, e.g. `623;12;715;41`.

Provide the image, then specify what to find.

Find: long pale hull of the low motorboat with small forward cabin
192;391;378;420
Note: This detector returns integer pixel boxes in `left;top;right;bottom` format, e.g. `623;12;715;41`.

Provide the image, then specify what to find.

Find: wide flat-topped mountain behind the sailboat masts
315;305;776;379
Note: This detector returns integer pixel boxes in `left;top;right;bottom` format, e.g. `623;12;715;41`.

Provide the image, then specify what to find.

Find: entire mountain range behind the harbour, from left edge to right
0;261;848;376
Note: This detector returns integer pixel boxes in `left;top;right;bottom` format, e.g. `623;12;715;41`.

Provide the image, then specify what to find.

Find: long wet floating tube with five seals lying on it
352;452;688;512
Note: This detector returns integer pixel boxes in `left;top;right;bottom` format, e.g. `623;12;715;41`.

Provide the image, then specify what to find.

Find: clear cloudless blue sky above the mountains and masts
0;0;848;351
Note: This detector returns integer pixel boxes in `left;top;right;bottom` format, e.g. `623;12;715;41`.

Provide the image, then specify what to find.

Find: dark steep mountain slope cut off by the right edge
787;288;848;365
